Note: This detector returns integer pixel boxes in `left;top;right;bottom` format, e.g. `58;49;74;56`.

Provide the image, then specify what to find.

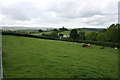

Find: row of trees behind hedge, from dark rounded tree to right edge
70;24;120;43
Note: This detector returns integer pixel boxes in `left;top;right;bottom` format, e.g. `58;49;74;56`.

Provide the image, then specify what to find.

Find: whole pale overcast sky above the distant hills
0;0;119;28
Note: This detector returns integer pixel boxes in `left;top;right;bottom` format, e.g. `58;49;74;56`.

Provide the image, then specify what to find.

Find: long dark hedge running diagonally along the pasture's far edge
2;32;120;48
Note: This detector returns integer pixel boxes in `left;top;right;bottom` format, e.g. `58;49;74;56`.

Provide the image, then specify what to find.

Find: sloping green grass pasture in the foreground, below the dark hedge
3;36;118;78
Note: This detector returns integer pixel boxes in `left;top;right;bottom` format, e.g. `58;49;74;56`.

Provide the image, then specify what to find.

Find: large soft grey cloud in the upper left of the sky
2;2;40;21
